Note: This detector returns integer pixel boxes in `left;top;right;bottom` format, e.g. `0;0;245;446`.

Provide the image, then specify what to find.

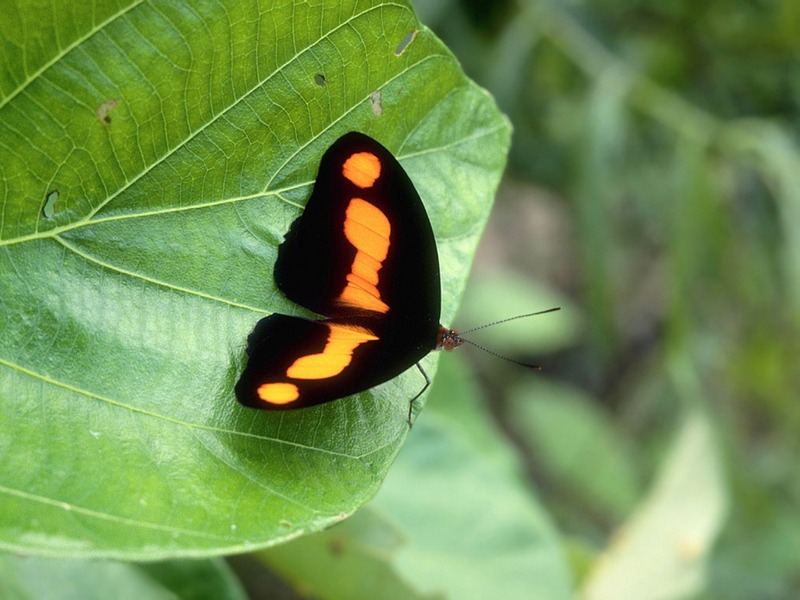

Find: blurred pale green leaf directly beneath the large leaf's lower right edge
262;356;572;600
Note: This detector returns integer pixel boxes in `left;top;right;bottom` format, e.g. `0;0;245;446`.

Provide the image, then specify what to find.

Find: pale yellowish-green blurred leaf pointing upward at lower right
582;411;727;600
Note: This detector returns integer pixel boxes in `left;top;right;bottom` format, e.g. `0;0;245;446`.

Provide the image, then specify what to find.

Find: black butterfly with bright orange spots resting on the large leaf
235;132;462;412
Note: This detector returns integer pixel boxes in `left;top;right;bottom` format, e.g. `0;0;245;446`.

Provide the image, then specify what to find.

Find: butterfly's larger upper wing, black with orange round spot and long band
275;132;441;325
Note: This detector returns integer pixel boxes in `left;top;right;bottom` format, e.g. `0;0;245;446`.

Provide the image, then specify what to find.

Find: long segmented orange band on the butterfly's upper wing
339;198;392;313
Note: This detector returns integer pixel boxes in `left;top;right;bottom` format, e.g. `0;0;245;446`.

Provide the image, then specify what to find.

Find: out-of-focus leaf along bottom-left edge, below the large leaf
0;556;247;600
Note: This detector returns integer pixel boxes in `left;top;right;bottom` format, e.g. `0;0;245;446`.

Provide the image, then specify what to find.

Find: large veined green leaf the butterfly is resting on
0;0;509;559
